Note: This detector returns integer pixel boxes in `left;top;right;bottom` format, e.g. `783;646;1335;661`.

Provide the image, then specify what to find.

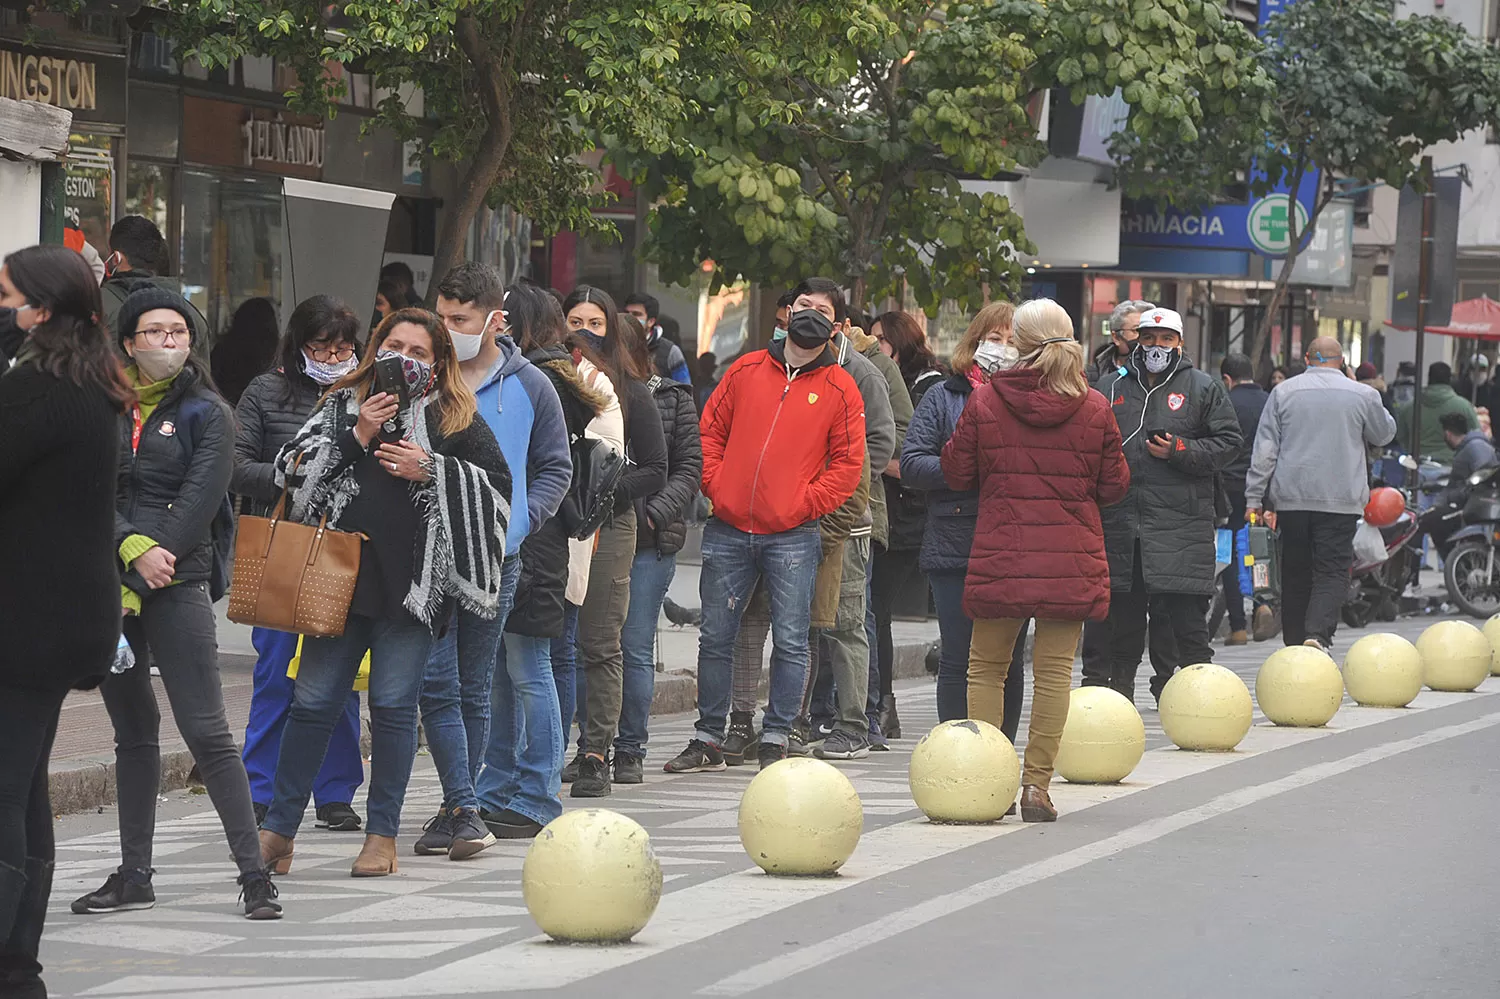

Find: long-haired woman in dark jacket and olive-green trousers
563;285;668;798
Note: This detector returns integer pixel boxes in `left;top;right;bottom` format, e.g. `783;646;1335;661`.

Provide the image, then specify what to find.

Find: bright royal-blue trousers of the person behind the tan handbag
242;629;365;809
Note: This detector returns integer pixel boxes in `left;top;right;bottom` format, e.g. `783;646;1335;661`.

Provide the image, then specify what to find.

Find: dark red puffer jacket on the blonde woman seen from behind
942;368;1130;621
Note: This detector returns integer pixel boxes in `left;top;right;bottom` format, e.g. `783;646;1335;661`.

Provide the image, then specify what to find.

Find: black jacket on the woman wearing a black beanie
114;363;234;596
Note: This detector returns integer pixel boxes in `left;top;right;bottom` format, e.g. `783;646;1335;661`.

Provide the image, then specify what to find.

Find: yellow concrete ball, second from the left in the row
740;756;864;876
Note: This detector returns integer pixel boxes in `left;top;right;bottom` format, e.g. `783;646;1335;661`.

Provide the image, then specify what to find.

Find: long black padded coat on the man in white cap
1094;356;1244;596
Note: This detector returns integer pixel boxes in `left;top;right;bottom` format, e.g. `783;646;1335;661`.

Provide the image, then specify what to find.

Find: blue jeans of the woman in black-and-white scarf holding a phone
263;614;432;837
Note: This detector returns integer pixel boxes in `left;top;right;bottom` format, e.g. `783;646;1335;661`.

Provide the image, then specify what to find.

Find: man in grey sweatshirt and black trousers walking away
1245;336;1397;651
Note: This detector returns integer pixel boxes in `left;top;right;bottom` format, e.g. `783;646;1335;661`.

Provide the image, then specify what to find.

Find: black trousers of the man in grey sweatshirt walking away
1277;510;1359;645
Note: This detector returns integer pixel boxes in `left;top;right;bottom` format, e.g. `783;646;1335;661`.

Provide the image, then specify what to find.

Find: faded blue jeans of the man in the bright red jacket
696;518;822;746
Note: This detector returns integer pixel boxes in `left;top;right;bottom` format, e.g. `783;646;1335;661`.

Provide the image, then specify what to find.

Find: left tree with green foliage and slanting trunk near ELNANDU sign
147;0;750;294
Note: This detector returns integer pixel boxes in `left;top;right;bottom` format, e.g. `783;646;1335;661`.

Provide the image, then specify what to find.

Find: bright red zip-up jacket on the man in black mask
701;342;870;534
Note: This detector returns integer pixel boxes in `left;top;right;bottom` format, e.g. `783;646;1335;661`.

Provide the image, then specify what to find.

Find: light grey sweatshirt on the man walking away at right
1245;368;1397;516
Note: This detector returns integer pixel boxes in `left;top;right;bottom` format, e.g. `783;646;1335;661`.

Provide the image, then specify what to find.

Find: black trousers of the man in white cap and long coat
1083;545;1214;701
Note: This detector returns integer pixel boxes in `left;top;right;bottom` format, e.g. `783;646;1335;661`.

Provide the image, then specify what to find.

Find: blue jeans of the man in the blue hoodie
422;555;521;810
